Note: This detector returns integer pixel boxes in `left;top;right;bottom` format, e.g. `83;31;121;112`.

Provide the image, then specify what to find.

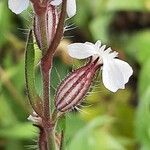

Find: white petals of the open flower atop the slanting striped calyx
68;41;133;92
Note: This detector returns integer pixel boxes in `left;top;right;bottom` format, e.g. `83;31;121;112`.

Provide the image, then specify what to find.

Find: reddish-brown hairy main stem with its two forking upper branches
38;0;66;150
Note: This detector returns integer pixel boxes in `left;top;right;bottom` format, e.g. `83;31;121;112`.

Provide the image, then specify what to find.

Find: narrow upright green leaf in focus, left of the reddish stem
25;31;41;114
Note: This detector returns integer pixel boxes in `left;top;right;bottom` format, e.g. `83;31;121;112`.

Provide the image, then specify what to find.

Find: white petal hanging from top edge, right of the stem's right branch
67;0;76;18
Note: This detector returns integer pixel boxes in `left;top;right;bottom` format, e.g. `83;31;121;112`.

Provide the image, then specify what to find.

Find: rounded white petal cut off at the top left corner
8;0;29;14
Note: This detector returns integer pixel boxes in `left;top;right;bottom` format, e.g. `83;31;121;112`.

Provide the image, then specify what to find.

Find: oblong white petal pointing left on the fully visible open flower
68;43;97;59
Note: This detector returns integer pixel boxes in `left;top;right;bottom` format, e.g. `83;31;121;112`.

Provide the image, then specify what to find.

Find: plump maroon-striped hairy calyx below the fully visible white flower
55;58;100;112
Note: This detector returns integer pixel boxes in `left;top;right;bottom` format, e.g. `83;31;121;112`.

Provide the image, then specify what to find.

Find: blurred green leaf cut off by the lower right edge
135;87;150;150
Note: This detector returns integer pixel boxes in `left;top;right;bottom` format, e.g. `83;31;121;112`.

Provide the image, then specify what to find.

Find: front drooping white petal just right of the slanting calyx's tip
102;59;125;92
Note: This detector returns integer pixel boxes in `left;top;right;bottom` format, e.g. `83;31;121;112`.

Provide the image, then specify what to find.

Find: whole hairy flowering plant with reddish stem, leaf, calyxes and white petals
8;0;133;150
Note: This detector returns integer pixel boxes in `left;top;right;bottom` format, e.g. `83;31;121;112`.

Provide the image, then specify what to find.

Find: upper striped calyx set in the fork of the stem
34;5;58;50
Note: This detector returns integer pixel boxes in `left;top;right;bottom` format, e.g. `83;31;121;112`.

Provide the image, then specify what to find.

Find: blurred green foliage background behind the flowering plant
0;0;150;150
